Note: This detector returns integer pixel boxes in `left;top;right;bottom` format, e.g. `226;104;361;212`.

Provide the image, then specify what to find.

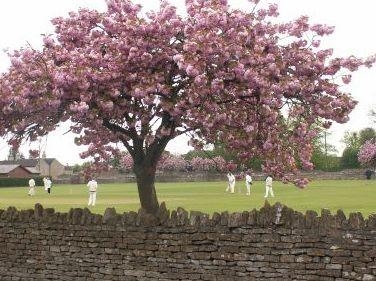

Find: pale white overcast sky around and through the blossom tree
0;0;376;165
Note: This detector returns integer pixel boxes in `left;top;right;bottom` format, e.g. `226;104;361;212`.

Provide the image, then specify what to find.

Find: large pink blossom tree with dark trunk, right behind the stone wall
0;0;374;213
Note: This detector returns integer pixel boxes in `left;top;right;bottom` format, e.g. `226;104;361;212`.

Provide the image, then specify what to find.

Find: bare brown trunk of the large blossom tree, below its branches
134;165;159;214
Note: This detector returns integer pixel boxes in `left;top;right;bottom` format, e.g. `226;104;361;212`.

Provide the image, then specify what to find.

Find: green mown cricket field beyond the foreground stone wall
0;180;376;216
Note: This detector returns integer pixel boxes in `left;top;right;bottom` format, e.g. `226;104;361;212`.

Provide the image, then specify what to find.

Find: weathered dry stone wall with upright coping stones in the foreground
0;204;376;281
